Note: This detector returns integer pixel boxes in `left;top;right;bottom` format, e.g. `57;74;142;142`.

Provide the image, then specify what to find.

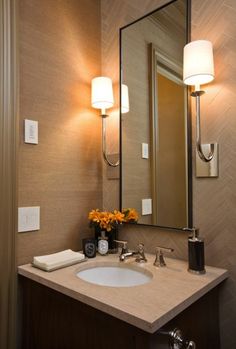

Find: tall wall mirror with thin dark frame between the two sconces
120;0;192;228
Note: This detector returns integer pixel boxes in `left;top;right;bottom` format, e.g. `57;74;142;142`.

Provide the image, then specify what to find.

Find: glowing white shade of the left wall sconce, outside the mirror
91;76;114;109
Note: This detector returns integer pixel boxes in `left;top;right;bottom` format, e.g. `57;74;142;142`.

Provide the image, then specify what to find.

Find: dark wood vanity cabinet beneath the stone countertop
18;276;220;349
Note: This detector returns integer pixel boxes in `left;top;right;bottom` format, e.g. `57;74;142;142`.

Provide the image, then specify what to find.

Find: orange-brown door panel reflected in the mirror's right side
156;72;187;227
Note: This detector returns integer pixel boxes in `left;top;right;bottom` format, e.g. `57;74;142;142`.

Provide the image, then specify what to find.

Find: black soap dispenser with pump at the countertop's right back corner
185;228;206;274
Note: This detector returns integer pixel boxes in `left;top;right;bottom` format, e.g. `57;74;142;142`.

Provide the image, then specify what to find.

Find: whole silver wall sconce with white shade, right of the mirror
183;40;218;177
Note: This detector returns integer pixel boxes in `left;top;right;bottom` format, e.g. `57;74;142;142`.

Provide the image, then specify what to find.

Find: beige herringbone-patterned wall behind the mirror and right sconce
102;0;236;349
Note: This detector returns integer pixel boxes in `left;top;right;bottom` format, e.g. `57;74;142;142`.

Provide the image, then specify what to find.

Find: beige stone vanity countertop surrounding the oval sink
18;254;228;333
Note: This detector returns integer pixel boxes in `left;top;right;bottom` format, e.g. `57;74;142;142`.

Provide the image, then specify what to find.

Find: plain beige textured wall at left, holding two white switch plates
18;0;102;264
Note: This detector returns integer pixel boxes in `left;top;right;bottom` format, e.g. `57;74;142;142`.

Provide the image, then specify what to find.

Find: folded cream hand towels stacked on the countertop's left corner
33;250;85;271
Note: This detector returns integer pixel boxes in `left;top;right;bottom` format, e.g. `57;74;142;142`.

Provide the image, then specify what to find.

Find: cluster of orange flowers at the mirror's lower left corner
88;208;139;232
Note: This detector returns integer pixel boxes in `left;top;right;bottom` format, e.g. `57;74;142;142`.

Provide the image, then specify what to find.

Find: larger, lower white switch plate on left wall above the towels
18;206;40;233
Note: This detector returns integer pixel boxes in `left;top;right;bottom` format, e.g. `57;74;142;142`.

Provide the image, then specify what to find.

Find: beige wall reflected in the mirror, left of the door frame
122;20;153;224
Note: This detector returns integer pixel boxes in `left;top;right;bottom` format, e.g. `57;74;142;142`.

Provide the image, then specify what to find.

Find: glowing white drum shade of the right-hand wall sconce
183;40;215;86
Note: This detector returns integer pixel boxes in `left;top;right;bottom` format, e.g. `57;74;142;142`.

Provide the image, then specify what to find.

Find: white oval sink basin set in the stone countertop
76;265;152;287
